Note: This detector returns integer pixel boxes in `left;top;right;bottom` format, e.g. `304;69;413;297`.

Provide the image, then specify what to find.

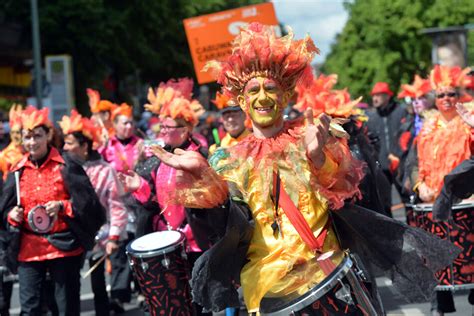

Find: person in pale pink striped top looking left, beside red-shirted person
59;110;128;315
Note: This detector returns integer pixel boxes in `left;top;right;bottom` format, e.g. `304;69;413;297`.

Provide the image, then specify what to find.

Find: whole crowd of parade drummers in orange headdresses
0;23;474;315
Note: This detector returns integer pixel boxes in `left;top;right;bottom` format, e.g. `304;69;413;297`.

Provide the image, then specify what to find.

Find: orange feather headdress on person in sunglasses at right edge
430;65;471;90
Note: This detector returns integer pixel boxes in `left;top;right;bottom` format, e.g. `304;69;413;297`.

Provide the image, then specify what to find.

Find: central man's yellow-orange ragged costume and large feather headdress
176;23;362;312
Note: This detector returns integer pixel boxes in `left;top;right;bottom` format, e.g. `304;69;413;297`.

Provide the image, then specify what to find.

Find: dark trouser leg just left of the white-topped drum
110;234;133;303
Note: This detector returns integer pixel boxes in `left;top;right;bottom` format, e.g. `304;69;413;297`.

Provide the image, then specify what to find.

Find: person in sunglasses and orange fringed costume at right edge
414;65;474;315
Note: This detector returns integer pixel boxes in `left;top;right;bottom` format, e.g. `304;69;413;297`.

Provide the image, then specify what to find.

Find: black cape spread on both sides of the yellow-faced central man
191;200;460;311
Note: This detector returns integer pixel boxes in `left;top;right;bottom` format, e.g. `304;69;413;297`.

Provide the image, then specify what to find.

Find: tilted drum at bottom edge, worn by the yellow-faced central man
260;256;378;316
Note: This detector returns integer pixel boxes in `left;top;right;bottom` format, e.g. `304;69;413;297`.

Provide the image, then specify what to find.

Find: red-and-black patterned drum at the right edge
413;200;474;291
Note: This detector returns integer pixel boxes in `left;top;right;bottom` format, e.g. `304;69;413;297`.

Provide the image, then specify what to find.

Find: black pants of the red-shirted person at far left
18;255;82;316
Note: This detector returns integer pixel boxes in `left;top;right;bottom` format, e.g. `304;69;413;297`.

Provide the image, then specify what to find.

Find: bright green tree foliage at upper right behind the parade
322;0;474;100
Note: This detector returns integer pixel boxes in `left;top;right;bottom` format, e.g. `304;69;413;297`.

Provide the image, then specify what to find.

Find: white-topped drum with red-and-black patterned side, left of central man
127;230;193;315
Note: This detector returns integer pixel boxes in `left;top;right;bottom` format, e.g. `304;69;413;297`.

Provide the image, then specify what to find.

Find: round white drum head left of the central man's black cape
128;230;184;253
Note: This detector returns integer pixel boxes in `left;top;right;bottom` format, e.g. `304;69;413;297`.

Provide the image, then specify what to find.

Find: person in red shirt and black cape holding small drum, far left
0;107;103;315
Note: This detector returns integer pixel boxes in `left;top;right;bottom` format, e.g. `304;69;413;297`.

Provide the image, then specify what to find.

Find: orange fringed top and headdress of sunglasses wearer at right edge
417;65;473;198
